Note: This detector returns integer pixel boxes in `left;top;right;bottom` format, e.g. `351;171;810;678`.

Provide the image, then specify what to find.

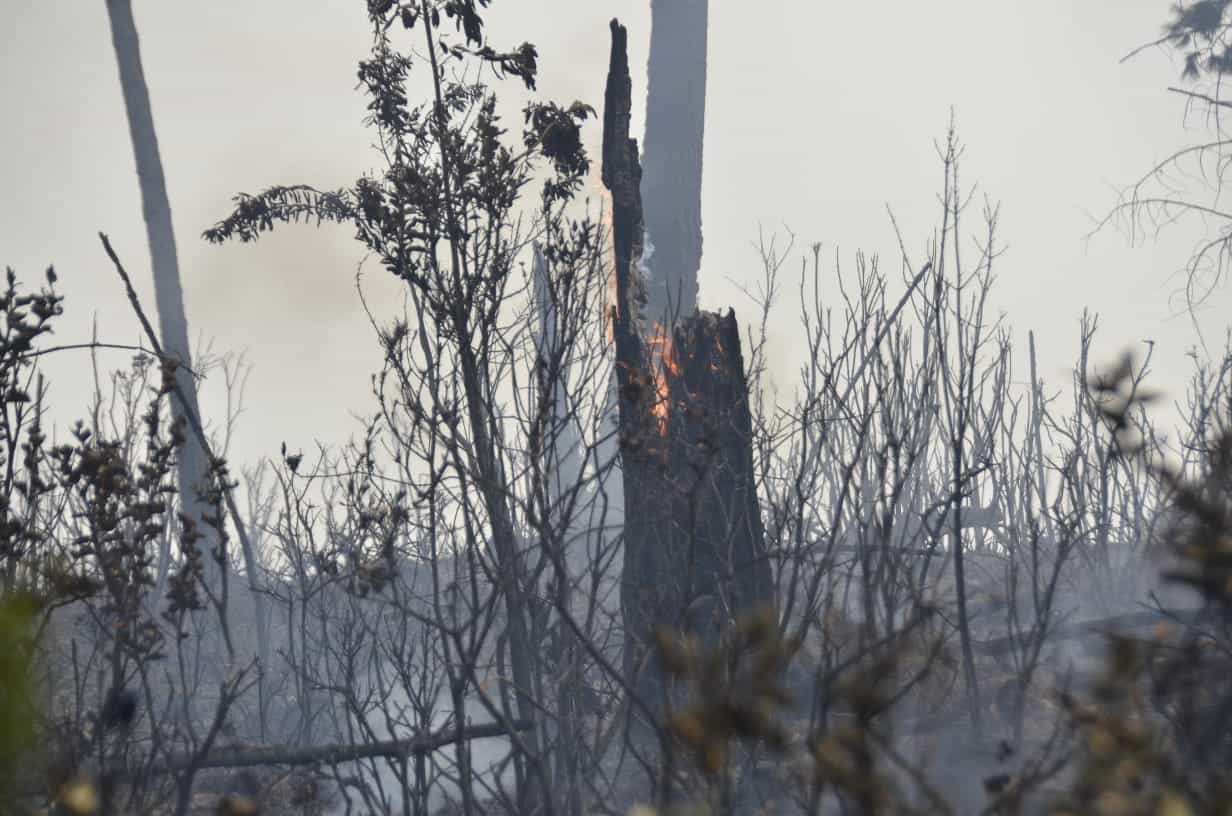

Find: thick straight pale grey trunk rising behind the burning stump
642;0;710;325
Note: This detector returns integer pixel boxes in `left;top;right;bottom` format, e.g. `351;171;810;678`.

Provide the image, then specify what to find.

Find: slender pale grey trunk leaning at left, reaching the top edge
106;0;269;726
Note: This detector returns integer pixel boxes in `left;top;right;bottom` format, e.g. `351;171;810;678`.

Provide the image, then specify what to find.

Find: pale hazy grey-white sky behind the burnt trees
0;0;1232;462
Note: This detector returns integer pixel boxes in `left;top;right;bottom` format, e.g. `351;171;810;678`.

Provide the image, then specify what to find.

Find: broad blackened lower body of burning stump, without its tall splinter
621;311;774;703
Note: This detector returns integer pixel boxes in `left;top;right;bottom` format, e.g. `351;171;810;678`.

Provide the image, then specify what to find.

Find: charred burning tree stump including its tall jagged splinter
602;20;772;706
